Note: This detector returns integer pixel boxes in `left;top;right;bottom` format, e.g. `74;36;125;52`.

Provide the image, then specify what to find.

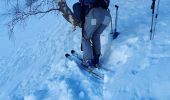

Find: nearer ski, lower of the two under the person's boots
65;53;104;80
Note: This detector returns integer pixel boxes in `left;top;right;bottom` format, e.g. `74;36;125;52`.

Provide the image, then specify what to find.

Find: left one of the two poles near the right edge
150;0;156;40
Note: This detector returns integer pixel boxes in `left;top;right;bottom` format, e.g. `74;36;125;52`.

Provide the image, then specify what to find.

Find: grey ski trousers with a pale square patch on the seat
82;7;111;60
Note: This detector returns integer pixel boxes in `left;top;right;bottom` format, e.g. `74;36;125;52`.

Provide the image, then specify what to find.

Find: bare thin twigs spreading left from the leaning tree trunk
2;0;59;39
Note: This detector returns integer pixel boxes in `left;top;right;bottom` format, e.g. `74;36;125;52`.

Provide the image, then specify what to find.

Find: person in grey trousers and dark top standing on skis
73;0;111;67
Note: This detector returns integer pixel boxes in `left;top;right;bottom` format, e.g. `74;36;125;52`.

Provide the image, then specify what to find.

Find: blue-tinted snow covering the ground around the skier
0;0;170;100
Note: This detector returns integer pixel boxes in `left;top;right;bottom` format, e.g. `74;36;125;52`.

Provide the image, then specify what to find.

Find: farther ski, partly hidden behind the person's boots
71;50;114;72
